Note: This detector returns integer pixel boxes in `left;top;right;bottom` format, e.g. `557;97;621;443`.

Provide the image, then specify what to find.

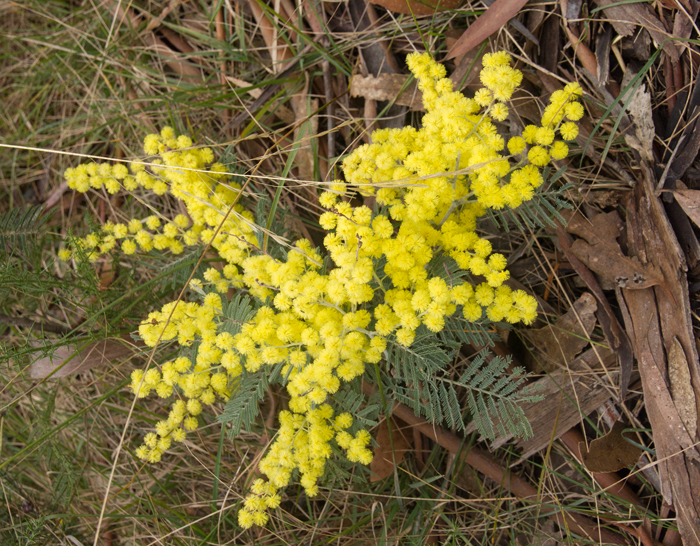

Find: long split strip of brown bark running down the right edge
618;166;700;544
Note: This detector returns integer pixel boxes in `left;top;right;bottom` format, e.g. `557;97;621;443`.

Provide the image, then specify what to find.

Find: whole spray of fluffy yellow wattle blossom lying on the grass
62;53;582;528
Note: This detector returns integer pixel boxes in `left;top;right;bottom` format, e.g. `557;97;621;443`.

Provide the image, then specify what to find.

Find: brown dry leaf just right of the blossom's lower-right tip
526;292;598;372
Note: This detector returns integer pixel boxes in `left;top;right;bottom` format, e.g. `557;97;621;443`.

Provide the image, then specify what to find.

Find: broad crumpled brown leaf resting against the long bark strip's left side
566;212;664;289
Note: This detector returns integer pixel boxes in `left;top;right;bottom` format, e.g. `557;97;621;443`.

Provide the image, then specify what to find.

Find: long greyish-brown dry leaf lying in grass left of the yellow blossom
29;339;134;379
